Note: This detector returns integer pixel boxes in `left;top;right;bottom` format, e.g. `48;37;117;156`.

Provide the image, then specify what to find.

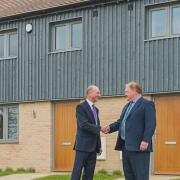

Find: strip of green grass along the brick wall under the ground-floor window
0;167;35;176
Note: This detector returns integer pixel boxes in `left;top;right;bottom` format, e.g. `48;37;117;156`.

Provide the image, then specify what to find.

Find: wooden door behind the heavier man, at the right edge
155;96;180;174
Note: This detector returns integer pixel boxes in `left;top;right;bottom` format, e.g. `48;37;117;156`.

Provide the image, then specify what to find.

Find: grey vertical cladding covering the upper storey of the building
0;0;180;103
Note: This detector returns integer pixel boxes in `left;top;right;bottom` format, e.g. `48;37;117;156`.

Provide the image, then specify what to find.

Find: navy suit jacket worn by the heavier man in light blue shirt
110;97;156;152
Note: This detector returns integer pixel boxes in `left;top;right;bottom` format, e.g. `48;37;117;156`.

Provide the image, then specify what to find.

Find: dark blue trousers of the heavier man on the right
122;148;150;180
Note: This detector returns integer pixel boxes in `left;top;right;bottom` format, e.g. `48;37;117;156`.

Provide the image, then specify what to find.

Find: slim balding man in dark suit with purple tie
71;85;102;180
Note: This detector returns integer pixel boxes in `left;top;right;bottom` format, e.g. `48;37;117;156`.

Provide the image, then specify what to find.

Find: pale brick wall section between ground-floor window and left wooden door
0;102;52;172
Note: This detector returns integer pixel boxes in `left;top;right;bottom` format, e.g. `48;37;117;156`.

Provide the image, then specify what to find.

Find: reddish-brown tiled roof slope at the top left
0;0;90;18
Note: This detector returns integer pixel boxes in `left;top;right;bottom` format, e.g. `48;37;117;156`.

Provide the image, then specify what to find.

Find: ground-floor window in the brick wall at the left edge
0;106;18;142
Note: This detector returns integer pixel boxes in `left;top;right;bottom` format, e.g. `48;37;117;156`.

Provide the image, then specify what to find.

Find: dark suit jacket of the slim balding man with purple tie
74;101;101;153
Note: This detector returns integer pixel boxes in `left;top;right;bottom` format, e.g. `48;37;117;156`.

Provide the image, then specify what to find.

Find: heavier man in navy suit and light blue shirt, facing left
103;82;156;180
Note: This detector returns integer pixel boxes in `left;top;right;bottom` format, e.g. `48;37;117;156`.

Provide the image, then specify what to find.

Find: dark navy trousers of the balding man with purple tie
71;151;96;180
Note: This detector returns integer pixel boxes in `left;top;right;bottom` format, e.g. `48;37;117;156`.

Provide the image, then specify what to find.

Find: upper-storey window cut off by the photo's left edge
0;32;18;59
